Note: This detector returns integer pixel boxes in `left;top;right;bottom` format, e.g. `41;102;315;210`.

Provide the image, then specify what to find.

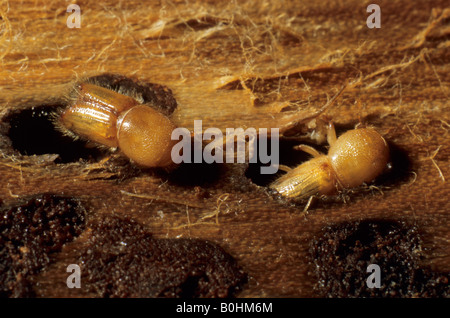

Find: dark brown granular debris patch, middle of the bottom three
78;216;247;298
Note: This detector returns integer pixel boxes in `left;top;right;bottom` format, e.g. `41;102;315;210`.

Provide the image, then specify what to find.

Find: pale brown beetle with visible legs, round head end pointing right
270;124;390;209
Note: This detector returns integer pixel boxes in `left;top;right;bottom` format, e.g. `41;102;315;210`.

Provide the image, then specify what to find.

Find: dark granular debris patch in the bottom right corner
310;220;450;298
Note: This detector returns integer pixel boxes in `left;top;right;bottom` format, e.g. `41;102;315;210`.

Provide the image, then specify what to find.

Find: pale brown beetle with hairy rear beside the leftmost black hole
56;77;176;167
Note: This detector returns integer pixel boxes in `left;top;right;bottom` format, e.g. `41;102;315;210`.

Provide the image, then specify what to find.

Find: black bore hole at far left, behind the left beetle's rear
4;105;106;163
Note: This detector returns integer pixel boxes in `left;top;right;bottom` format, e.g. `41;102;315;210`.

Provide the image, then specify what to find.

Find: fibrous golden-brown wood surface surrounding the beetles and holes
0;0;450;297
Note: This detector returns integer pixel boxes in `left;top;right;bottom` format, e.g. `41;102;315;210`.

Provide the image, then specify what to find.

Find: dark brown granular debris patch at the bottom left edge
0;194;86;297
